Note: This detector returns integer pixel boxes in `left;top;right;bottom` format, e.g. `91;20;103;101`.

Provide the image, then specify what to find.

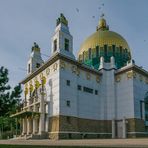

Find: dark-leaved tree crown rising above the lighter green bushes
0;67;22;116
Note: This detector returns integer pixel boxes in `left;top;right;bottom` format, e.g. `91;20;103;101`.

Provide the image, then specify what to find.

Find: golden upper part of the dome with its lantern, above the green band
78;18;130;55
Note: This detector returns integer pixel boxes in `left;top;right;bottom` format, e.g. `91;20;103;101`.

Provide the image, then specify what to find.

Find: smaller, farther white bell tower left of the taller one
27;42;44;74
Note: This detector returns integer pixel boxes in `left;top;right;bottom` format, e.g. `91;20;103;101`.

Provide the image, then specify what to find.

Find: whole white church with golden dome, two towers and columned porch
12;14;148;139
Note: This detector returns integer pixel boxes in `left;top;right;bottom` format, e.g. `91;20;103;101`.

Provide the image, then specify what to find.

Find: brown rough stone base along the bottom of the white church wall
49;116;148;139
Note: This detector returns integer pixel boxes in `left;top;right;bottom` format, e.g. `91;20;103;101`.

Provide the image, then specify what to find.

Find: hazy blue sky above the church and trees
0;0;148;86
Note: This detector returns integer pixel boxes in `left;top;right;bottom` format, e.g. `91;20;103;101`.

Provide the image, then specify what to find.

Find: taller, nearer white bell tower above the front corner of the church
51;13;75;58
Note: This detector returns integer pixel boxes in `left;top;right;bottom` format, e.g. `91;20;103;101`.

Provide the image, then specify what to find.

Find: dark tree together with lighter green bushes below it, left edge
0;67;22;139
